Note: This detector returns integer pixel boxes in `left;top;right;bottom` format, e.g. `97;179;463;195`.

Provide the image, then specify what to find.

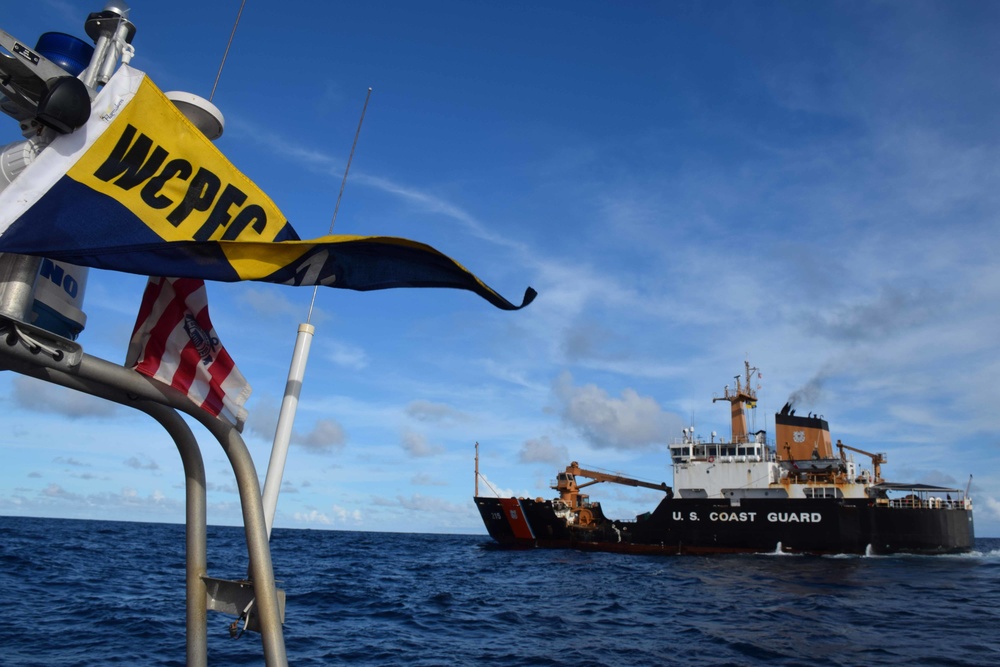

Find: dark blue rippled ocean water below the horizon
0;517;1000;667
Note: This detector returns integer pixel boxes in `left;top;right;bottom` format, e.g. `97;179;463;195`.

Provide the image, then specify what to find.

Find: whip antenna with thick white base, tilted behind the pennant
261;88;372;539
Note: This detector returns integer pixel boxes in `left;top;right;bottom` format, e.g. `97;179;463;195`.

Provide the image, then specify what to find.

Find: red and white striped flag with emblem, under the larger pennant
125;278;251;430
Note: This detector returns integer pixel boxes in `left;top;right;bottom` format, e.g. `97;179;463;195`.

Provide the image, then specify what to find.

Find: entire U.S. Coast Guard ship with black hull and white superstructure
475;362;975;554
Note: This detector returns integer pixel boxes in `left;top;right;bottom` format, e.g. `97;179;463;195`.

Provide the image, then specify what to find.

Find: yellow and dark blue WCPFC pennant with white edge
0;66;535;310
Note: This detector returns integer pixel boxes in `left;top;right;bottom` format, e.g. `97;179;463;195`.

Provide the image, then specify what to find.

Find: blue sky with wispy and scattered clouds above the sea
0;0;1000;536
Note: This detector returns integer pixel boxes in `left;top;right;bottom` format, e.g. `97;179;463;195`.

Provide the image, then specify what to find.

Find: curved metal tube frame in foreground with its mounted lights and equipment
0;5;290;666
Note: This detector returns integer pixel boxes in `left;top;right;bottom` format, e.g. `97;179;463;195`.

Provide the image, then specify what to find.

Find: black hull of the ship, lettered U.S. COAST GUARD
475;498;975;554
